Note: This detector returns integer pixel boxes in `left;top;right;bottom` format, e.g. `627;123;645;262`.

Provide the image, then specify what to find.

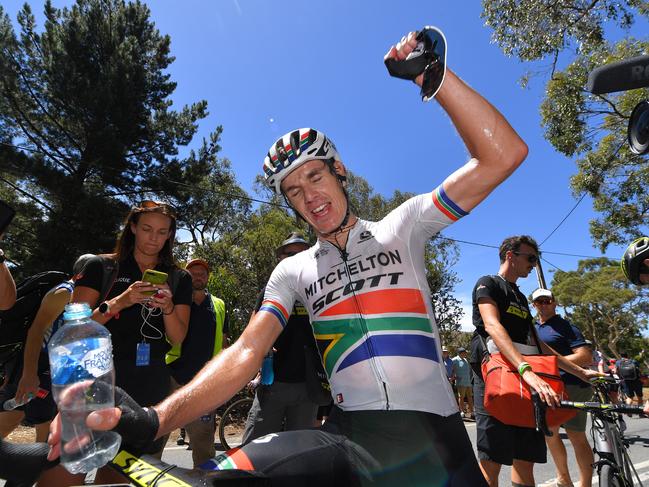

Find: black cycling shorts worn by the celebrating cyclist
201;407;487;487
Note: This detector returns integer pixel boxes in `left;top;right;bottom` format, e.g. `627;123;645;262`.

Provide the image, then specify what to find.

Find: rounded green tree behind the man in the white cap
552;258;649;357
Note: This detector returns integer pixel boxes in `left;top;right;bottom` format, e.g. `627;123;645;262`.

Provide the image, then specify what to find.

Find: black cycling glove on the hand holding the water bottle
114;387;165;456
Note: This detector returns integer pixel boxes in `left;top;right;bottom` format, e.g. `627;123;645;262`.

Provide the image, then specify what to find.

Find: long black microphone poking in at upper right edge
586;55;649;95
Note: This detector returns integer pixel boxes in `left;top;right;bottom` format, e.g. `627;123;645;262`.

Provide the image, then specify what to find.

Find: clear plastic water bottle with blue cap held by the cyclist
48;303;122;473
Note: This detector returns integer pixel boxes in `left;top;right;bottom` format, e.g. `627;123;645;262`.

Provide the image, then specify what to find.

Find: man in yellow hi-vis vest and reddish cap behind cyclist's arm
167;259;229;468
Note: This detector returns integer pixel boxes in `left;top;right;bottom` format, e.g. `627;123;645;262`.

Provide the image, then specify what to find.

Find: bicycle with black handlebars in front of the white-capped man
532;377;643;487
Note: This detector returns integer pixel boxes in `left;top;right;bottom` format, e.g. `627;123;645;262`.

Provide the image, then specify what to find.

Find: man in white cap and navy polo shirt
532;289;594;487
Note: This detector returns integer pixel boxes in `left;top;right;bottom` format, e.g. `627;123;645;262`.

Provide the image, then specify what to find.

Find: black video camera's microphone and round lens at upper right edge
586;55;649;155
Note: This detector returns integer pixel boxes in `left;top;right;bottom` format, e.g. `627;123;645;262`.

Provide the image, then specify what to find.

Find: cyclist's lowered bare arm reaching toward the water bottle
155;312;282;437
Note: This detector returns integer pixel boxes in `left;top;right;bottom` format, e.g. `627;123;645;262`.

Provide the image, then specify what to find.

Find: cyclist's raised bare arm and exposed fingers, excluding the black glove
386;32;527;211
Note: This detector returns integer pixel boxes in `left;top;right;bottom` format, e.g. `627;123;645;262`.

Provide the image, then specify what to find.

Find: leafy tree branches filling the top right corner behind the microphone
482;0;649;251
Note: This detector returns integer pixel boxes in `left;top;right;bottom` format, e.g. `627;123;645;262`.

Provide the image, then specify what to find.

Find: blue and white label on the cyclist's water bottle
50;338;113;385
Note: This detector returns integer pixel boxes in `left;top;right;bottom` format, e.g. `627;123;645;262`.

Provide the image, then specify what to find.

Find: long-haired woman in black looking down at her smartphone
72;201;192;466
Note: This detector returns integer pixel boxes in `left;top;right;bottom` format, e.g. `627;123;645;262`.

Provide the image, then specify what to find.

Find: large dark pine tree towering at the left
0;0;248;273
